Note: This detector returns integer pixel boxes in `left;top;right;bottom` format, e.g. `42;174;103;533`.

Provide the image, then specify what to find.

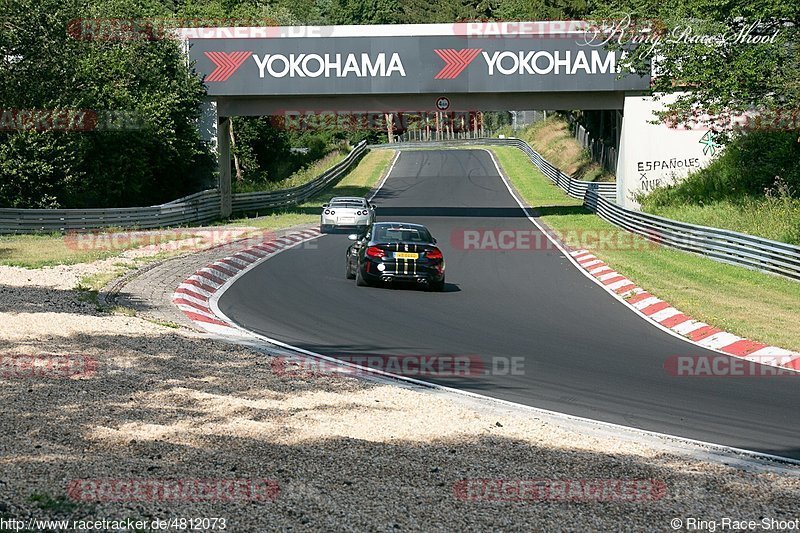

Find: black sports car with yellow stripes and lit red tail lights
346;222;444;291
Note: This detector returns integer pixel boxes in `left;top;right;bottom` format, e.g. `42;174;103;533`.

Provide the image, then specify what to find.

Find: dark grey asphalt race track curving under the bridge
219;150;800;459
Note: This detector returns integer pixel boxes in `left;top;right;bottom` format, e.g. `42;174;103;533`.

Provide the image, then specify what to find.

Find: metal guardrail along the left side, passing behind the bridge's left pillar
0;141;367;234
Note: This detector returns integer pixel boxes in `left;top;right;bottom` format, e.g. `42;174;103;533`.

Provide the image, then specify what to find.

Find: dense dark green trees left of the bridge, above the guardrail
0;0;212;207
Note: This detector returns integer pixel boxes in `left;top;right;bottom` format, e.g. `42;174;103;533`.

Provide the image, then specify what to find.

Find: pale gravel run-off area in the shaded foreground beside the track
0;239;800;531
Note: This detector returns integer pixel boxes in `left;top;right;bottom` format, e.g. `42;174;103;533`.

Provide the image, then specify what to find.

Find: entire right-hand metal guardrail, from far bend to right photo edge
372;138;800;280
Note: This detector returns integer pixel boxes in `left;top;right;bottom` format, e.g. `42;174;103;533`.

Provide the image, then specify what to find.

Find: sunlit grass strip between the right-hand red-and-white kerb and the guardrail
490;147;800;351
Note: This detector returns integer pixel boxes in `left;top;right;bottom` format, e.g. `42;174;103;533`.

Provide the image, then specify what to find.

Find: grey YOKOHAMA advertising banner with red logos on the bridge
189;33;650;96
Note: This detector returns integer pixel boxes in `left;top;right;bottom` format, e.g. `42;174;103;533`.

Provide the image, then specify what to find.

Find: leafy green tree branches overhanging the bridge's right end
592;0;800;132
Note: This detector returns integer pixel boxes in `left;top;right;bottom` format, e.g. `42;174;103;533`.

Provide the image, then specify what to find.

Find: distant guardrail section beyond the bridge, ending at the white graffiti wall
369;138;617;202
